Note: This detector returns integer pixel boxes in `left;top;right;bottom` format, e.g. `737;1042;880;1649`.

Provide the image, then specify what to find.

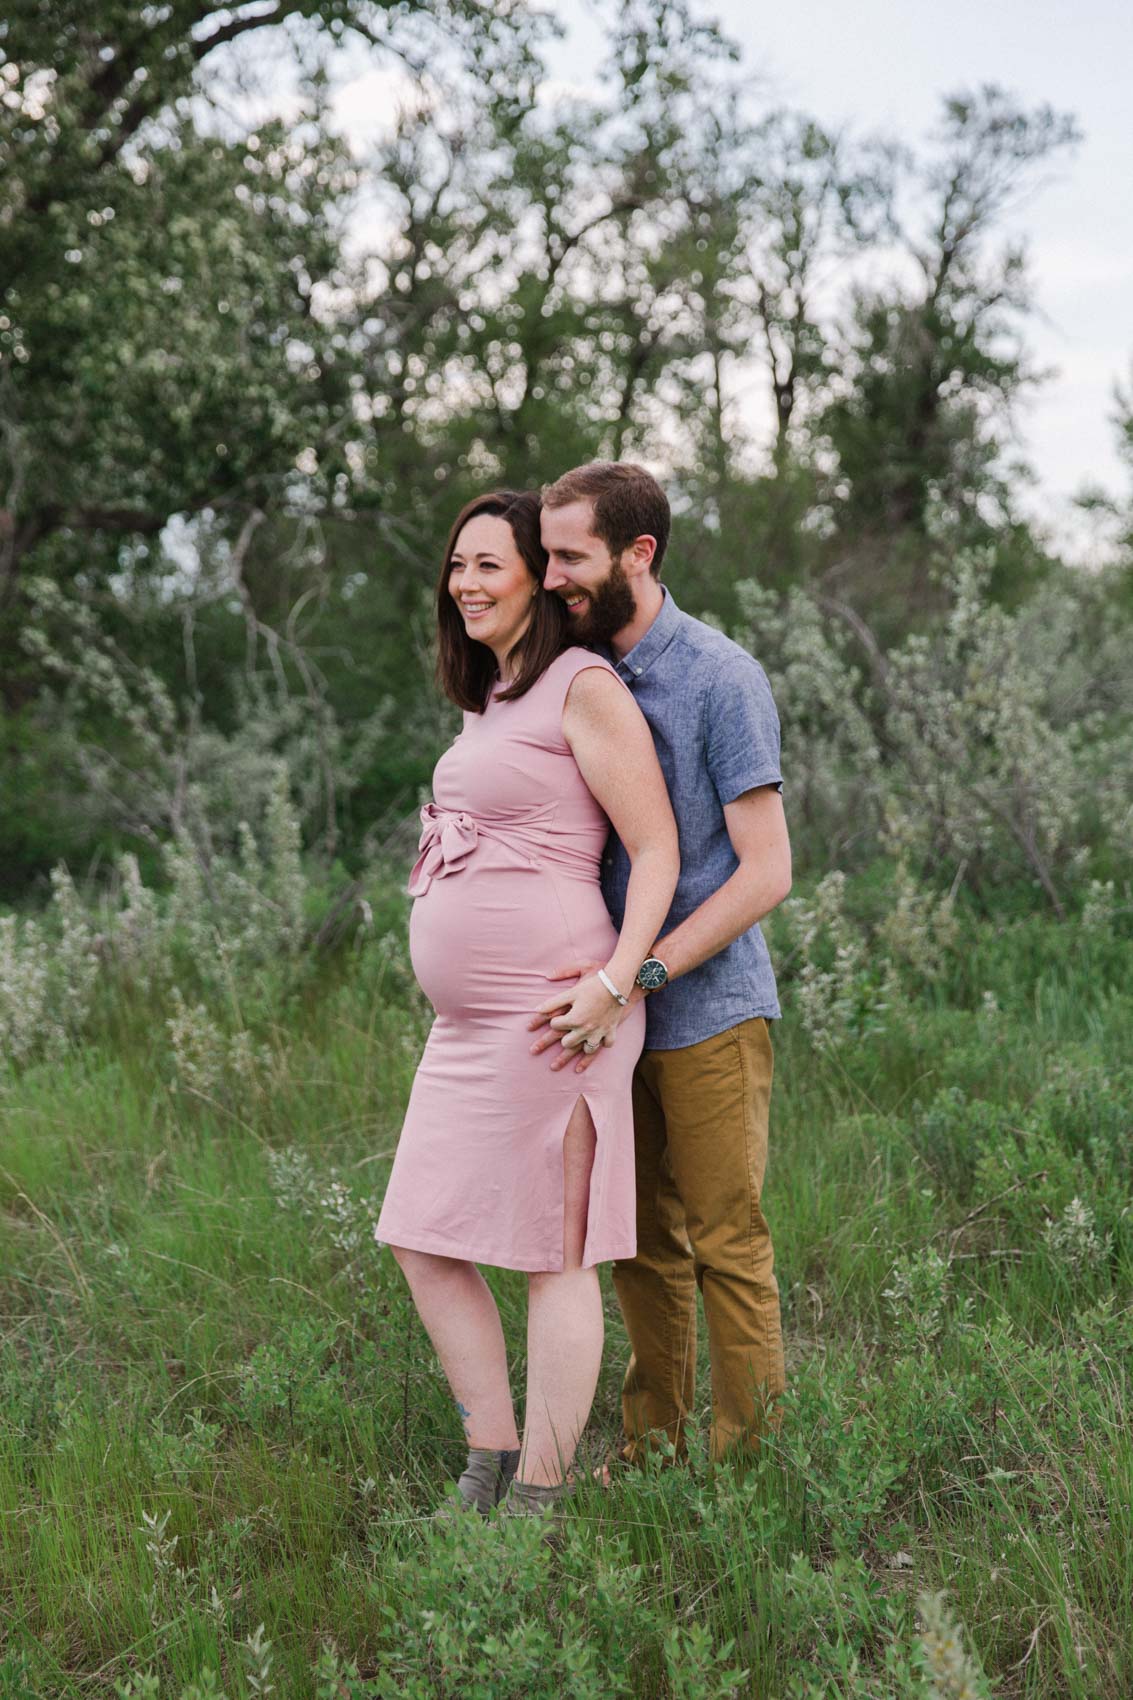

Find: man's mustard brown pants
612;1017;784;1462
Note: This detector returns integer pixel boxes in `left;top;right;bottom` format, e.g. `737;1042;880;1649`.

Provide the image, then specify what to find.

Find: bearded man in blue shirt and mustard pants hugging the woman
531;461;791;1464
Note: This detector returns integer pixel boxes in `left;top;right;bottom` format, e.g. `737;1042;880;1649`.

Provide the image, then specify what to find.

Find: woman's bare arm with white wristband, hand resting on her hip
551;666;680;1051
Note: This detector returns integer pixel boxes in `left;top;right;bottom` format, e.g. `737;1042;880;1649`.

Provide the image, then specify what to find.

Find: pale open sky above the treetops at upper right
549;0;1133;559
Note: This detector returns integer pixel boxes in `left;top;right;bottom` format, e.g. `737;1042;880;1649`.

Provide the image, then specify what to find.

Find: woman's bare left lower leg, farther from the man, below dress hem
390;1246;519;1452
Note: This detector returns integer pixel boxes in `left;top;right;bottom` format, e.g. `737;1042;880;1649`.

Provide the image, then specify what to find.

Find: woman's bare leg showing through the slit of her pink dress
515;1098;604;1488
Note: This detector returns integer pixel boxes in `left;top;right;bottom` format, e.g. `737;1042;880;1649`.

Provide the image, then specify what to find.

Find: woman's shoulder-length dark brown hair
437;490;567;714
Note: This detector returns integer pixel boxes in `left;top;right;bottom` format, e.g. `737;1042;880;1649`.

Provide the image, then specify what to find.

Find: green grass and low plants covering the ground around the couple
0;921;1133;1700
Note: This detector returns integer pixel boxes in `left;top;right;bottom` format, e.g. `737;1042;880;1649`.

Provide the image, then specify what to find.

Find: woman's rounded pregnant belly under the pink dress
410;859;618;1020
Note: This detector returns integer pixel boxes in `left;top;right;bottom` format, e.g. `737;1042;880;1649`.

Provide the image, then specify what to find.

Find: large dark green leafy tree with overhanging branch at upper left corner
0;0;534;605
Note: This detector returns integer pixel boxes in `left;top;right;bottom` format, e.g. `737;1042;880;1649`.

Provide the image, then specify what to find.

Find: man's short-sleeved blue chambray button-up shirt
602;587;783;1051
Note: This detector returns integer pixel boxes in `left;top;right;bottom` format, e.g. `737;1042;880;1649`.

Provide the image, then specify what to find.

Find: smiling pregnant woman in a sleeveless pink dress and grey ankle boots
376;491;677;1516
